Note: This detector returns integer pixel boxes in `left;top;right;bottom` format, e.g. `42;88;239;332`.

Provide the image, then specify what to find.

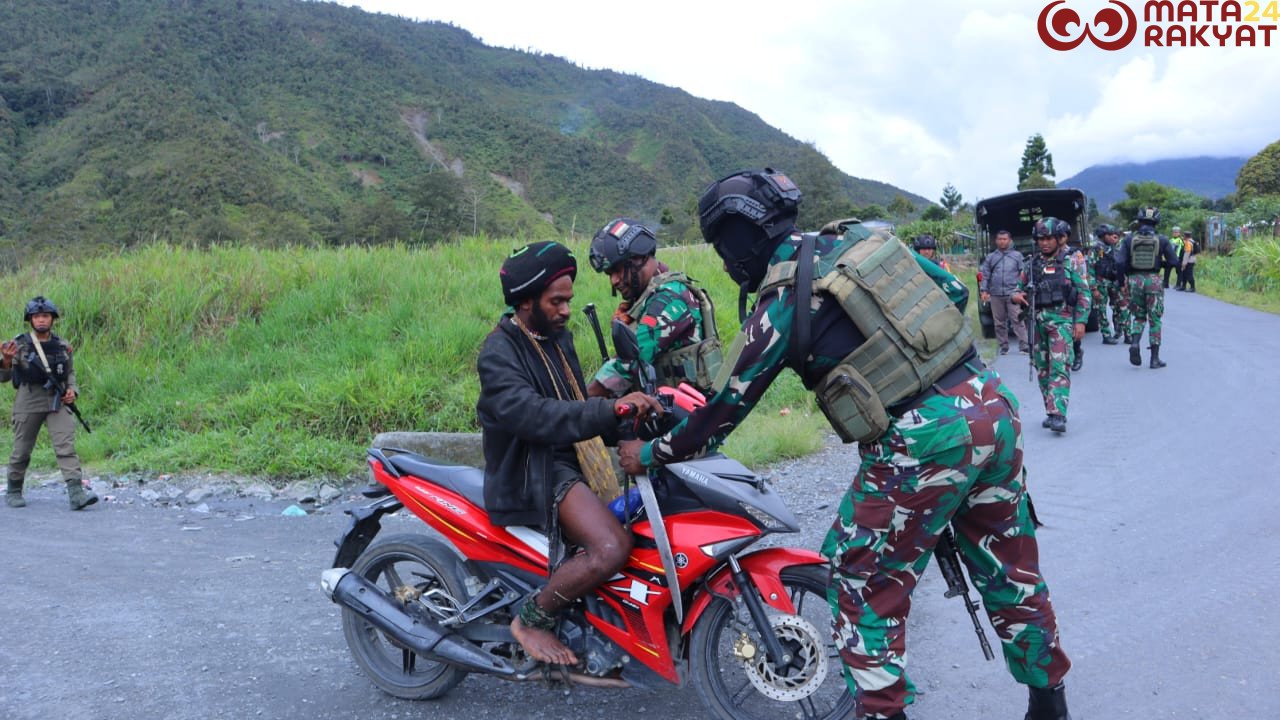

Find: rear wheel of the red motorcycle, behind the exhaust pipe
342;534;467;700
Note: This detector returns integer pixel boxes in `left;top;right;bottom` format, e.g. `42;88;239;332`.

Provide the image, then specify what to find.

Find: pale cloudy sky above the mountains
339;0;1280;201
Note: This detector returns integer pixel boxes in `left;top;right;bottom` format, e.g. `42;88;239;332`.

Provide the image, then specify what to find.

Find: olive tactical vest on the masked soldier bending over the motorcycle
759;229;973;442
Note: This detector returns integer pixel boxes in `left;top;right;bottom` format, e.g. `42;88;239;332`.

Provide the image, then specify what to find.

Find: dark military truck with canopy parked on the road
974;188;1098;338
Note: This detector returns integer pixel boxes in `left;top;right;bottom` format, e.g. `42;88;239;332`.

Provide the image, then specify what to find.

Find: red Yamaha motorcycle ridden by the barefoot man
321;328;854;720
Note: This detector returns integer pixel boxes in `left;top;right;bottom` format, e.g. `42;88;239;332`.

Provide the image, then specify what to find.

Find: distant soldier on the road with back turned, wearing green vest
1116;208;1178;370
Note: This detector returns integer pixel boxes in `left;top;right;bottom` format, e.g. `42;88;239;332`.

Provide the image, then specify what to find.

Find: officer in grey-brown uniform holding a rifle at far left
0;296;97;510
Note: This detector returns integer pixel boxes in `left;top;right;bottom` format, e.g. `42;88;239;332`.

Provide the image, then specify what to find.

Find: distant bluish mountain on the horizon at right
1057;158;1248;213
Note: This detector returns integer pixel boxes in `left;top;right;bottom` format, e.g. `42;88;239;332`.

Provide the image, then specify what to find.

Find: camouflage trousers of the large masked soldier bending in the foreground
822;370;1071;716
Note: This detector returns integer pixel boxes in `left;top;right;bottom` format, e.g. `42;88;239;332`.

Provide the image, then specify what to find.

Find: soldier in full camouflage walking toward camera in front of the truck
1014;218;1092;433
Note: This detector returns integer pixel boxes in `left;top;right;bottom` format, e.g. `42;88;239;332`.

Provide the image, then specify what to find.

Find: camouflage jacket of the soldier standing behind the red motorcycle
594;266;703;395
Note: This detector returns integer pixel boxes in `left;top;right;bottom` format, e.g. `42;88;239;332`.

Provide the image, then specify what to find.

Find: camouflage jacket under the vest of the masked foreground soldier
640;225;969;465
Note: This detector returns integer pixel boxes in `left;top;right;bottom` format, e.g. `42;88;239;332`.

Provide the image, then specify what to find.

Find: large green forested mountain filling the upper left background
0;0;929;266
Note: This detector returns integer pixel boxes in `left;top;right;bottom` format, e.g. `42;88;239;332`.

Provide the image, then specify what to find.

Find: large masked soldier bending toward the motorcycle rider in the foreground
620;169;1070;720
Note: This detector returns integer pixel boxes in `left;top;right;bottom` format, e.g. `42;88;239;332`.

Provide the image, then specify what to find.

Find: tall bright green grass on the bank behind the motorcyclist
0;240;826;478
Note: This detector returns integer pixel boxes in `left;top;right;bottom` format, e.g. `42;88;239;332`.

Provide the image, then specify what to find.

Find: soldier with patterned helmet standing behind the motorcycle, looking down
588;218;721;397
